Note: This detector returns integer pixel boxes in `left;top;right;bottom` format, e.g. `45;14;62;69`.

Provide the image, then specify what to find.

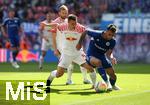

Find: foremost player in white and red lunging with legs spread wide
46;14;96;86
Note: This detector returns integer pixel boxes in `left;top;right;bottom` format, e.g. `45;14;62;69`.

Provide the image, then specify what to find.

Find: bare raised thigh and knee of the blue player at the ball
86;56;102;67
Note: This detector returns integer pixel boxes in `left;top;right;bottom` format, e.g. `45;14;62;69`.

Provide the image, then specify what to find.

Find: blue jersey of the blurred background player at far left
3;18;20;37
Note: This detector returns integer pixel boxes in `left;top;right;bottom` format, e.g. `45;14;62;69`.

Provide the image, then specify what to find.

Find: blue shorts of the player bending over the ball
86;55;112;69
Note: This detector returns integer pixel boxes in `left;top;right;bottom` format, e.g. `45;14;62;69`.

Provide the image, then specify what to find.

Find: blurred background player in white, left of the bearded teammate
39;12;57;69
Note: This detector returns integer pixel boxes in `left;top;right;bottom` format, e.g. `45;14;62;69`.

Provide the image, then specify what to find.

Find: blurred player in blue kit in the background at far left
1;9;22;68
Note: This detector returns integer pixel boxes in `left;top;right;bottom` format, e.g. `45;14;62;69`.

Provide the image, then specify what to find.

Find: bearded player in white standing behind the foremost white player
53;5;91;85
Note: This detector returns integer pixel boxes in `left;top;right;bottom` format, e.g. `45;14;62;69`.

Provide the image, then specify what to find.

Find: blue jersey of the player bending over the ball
87;30;116;57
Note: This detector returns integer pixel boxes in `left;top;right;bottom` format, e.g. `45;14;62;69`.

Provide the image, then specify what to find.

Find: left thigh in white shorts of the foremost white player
58;54;73;69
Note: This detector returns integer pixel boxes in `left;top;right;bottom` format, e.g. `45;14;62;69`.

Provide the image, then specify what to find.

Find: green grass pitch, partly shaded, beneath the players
0;63;150;105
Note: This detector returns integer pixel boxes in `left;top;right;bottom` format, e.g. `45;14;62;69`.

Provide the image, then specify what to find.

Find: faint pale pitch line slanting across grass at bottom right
63;90;150;105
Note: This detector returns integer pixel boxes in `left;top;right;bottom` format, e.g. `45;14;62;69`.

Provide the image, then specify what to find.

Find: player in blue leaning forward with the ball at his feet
76;24;120;90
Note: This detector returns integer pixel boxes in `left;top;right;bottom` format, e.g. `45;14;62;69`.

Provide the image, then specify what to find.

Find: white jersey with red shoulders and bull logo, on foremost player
58;23;85;56
